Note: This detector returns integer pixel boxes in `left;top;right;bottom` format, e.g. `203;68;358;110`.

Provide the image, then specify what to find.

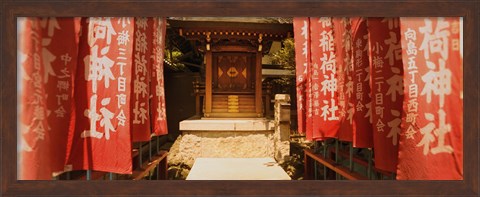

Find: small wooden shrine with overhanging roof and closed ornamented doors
169;20;293;118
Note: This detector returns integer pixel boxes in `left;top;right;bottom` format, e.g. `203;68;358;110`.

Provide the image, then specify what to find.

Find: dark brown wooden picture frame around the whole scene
0;0;480;196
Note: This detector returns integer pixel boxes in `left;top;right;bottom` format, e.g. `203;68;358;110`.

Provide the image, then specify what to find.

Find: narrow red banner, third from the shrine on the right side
332;18;354;142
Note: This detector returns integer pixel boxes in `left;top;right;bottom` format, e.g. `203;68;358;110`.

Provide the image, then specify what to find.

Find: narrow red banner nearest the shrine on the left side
150;18;168;136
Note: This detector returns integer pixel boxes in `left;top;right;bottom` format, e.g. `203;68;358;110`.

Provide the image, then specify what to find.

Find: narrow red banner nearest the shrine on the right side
293;18;312;140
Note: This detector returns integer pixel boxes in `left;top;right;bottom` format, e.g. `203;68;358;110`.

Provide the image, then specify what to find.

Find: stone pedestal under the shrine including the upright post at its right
172;95;290;167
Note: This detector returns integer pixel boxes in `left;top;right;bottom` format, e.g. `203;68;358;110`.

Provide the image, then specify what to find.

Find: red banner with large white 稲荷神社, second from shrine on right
310;17;339;140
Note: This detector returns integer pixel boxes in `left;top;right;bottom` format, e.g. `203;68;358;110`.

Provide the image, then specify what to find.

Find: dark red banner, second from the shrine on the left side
130;18;153;142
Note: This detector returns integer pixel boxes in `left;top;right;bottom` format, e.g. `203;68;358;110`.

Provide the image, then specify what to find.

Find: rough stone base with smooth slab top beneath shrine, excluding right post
168;119;275;167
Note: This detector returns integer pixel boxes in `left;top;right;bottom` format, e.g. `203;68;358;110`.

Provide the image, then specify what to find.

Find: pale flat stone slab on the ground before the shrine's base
187;158;291;180
